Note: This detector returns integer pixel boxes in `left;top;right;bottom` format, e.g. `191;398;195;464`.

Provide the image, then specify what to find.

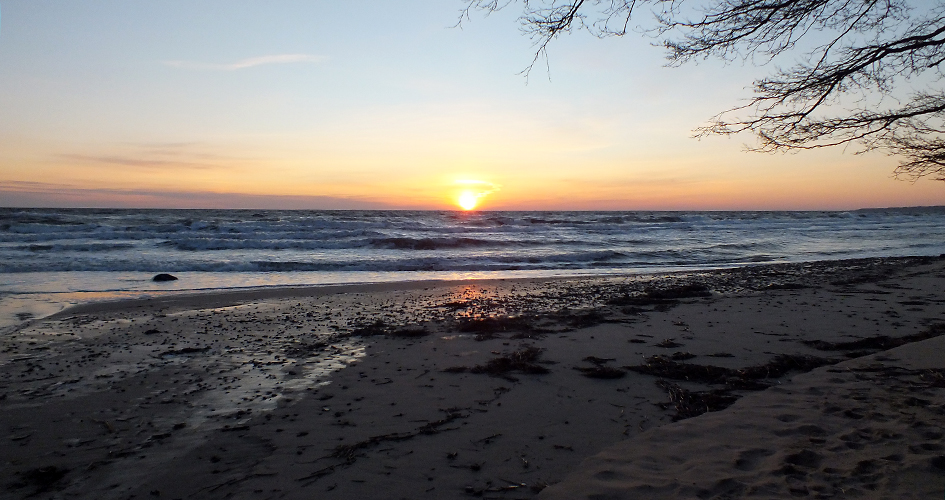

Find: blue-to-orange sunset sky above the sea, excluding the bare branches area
0;0;945;210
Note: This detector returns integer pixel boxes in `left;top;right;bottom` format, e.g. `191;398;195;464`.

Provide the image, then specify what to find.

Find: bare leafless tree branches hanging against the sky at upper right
463;0;945;180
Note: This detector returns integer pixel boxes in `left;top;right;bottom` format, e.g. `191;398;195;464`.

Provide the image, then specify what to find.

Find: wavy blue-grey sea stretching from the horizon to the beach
0;207;945;328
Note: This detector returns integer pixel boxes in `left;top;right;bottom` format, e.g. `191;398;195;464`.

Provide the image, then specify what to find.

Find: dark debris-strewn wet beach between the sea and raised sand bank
0;257;945;498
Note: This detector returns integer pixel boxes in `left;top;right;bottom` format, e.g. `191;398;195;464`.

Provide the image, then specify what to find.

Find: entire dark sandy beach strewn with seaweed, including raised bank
0;258;945;499
